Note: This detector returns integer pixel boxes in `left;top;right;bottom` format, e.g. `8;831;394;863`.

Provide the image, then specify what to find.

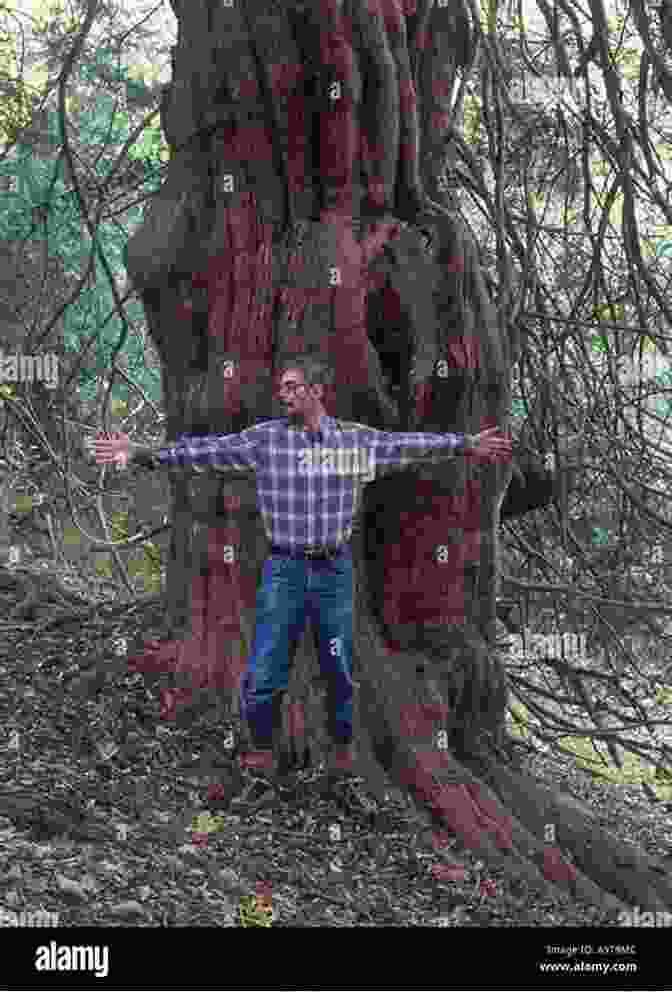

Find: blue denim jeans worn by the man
240;546;353;748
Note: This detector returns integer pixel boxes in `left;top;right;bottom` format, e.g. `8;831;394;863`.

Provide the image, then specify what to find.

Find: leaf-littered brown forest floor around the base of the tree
0;600;672;927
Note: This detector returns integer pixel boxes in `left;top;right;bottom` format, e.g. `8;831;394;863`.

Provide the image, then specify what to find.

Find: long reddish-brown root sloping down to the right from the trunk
355;536;672;913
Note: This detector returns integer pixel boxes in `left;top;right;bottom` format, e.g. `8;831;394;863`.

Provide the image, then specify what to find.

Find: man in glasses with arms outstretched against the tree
95;356;511;784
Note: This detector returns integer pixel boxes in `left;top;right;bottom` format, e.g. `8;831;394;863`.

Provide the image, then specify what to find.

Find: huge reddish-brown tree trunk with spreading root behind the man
122;0;672;909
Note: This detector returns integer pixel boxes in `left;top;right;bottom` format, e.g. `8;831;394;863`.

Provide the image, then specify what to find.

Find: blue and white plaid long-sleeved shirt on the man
157;416;464;550
